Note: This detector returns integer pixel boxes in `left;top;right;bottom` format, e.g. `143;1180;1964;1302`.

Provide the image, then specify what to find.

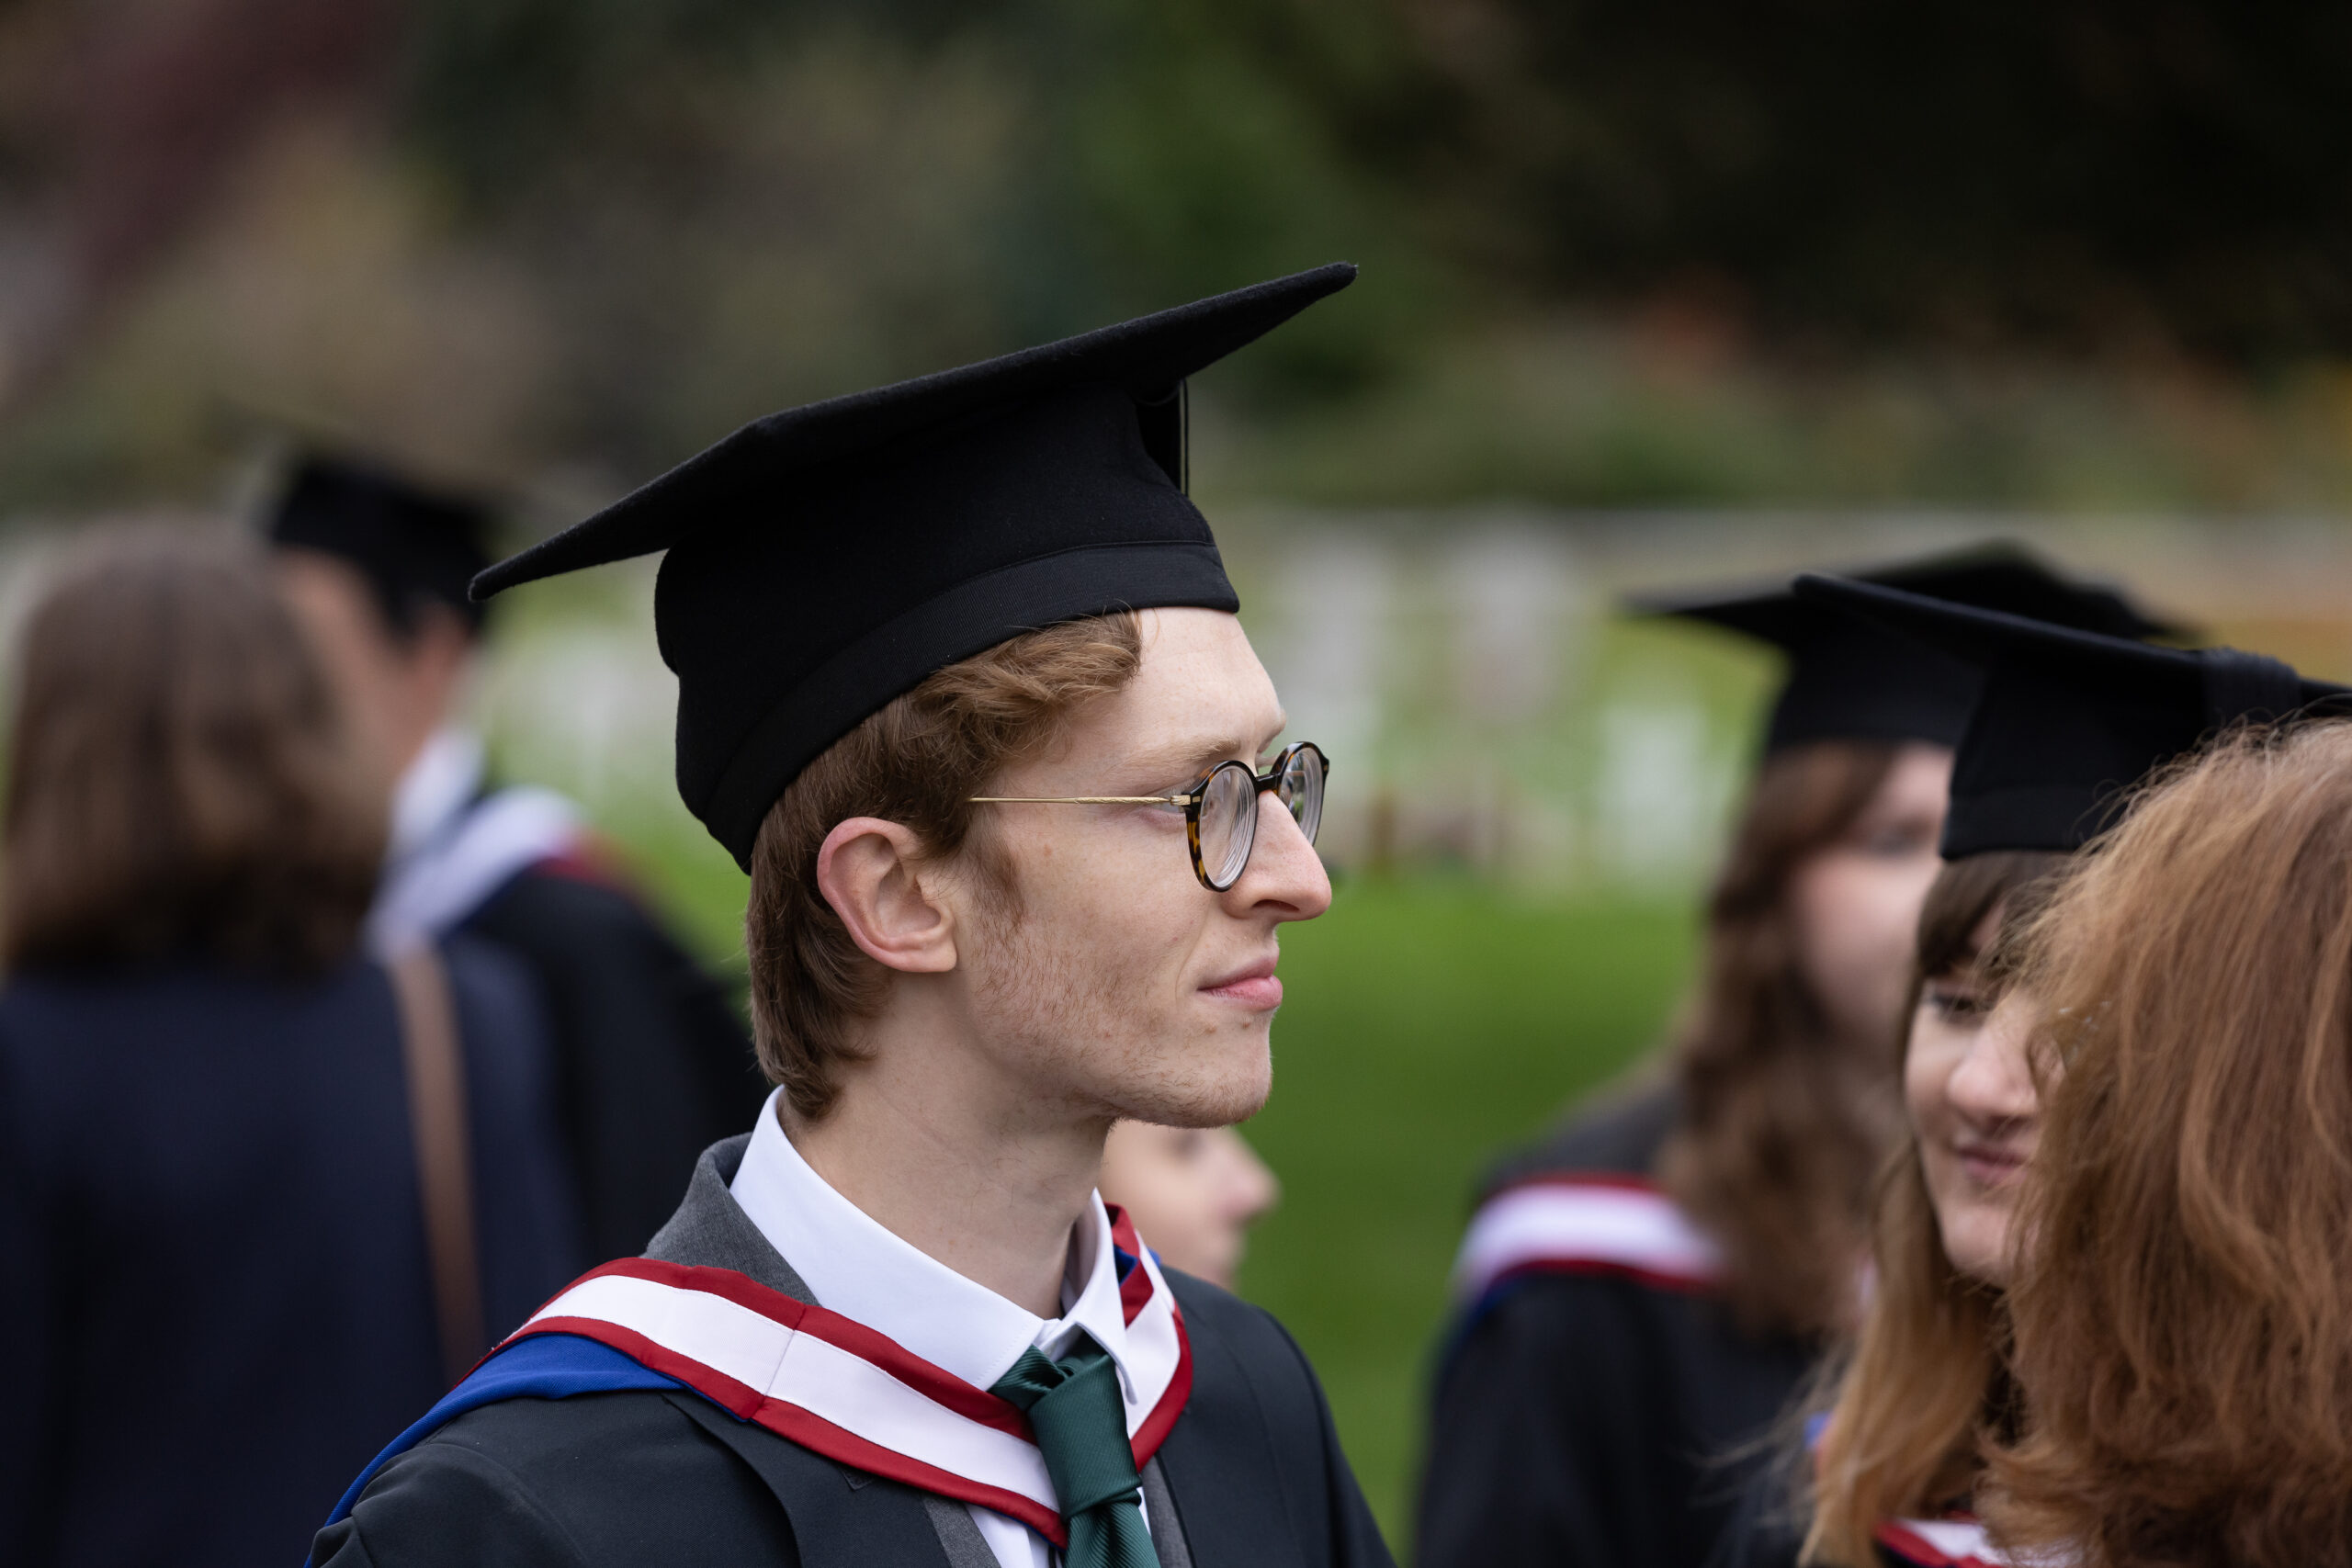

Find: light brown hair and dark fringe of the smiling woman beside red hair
1804;851;2067;1568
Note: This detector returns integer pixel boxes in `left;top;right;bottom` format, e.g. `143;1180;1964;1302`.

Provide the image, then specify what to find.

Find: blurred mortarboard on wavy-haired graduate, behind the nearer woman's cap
1630;543;2180;755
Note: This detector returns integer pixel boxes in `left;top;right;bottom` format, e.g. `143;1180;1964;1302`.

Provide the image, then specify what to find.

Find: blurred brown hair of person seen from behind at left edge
0;534;386;971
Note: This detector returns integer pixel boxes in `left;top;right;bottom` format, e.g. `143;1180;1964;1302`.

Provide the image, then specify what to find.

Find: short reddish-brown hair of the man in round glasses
743;611;1143;1122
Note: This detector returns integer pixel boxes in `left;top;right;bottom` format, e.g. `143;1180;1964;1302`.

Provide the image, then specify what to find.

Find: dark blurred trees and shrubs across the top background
14;0;2352;525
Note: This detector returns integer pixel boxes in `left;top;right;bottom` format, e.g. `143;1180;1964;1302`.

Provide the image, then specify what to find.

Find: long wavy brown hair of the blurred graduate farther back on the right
1658;740;1895;1336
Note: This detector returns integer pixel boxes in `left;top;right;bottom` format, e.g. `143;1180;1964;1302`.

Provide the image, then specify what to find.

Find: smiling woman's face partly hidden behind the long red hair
1903;909;2041;1286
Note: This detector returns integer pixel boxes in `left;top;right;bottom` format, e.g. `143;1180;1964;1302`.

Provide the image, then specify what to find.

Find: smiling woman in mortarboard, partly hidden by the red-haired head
1714;576;2352;1568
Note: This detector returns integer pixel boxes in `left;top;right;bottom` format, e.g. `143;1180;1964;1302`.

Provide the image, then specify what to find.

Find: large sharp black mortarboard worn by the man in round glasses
475;264;1355;865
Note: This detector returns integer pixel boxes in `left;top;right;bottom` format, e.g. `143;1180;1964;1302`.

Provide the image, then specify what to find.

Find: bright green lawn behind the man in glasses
626;831;1696;1556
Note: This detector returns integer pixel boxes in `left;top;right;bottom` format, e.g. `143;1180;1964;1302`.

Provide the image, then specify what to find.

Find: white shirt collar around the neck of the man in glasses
731;1089;1136;1401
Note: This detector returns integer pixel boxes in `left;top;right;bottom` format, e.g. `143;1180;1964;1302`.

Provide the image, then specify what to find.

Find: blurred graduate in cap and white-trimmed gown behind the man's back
268;454;762;1259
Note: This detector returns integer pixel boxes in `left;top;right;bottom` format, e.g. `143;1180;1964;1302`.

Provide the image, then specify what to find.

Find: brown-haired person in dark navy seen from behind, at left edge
0;538;583;1568
